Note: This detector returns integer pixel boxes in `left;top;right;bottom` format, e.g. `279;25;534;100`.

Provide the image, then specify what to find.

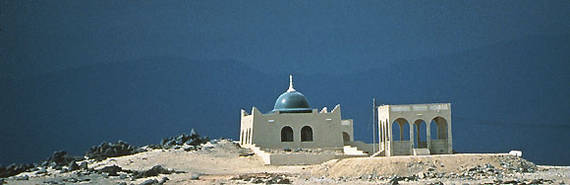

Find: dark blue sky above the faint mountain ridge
0;0;570;77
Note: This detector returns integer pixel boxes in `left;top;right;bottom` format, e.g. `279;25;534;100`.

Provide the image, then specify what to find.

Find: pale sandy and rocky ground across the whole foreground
0;133;570;185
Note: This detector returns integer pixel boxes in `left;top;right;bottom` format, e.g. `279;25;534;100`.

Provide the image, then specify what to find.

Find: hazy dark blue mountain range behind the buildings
0;35;570;165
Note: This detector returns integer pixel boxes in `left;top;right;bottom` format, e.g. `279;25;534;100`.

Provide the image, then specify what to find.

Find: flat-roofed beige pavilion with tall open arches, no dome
377;103;453;156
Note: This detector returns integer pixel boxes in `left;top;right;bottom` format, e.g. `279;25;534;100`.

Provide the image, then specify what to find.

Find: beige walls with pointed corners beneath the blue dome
240;105;346;150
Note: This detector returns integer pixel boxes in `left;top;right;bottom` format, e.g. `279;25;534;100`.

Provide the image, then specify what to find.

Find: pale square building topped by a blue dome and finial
240;76;353;150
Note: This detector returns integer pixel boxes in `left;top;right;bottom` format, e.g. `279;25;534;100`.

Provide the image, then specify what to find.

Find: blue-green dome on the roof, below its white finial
273;91;312;113
